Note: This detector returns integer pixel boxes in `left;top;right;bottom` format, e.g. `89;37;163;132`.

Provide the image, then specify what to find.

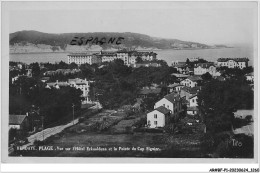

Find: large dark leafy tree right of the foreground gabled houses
198;80;254;132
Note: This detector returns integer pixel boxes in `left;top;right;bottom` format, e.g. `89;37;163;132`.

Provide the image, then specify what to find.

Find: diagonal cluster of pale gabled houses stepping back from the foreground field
147;84;201;128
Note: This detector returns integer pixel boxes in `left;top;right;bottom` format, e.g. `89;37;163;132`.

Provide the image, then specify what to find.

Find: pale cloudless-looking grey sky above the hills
9;2;257;44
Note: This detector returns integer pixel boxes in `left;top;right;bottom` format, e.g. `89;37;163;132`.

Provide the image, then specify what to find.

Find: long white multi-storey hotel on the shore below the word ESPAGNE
68;50;157;65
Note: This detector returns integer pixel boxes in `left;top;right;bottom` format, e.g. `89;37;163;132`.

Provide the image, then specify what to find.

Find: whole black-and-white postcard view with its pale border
1;1;259;166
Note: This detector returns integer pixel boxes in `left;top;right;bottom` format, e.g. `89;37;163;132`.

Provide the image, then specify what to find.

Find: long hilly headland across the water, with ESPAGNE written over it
9;31;221;53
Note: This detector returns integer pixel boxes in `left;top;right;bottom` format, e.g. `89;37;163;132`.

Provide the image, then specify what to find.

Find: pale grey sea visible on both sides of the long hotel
9;47;257;65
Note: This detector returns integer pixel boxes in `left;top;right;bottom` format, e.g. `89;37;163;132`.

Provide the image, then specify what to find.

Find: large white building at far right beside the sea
217;58;249;69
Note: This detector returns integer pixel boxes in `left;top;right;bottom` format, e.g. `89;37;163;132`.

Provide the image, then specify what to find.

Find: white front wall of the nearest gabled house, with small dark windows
147;110;166;128
